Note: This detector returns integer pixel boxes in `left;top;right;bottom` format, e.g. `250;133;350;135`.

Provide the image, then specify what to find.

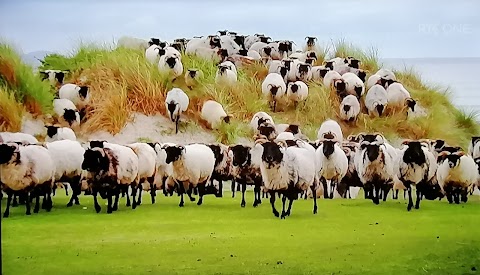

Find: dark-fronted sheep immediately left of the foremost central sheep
229;144;262;207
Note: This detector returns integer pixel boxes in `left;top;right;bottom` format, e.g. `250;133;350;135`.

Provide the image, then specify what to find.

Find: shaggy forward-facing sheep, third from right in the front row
355;134;395;204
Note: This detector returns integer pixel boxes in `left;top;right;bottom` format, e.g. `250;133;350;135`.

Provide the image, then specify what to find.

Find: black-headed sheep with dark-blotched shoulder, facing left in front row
82;143;139;214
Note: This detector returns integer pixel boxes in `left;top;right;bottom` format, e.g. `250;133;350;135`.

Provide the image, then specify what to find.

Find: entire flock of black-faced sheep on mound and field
0;31;480;218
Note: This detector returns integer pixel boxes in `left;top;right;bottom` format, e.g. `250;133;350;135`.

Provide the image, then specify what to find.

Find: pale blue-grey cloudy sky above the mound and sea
0;0;480;58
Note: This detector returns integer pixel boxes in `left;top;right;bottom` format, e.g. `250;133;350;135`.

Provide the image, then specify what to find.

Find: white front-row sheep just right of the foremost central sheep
315;140;348;199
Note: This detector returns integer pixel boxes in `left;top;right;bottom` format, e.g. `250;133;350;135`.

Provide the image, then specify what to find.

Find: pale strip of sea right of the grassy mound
380;57;480;118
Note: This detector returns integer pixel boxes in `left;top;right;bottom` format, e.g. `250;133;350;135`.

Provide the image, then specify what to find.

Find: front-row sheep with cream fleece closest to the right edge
437;151;479;204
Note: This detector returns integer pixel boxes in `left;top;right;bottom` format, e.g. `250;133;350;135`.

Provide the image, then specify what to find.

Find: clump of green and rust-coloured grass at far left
0;43;54;115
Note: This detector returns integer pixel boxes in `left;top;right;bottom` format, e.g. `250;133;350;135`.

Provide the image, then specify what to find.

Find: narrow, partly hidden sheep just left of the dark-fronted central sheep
207;144;232;197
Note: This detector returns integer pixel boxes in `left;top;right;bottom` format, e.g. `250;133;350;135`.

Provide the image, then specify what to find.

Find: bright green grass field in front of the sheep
1;191;480;274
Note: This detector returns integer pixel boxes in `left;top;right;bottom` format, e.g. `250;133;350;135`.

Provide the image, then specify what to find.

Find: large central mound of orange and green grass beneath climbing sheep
32;41;477;147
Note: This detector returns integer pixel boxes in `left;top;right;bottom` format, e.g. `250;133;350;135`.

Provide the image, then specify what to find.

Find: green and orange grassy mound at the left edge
0;43;54;131
